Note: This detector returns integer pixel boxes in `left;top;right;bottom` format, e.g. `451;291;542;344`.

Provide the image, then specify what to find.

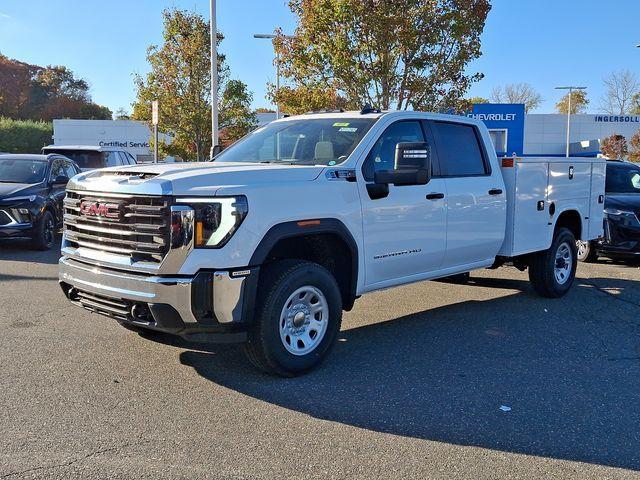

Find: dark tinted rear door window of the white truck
431;122;488;177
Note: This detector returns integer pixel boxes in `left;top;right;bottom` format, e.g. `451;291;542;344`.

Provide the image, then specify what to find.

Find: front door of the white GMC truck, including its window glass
358;119;446;289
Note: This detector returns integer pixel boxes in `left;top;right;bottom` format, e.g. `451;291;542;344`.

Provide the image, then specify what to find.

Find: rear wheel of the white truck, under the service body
529;228;577;298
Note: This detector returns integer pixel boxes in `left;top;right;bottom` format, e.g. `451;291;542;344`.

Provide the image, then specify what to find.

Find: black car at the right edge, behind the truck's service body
578;160;640;262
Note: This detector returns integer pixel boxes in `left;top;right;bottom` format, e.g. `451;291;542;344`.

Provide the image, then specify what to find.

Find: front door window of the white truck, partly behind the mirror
362;120;425;181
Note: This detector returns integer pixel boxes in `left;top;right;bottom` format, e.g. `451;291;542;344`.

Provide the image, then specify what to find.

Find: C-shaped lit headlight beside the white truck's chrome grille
177;196;249;248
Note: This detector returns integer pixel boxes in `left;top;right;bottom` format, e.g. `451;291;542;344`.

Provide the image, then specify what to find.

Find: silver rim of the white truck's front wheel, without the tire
280;285;329;356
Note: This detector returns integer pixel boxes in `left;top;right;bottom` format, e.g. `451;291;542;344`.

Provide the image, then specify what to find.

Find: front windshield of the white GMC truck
215;118;376;165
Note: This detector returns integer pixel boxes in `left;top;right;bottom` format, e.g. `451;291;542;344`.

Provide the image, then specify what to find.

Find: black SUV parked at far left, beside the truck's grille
0;154;80;250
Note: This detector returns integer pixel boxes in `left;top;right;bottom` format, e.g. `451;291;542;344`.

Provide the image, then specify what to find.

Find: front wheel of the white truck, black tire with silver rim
245;260;342;377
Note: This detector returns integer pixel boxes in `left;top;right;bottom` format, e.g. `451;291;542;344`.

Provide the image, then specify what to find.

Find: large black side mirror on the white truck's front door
374;142;431;186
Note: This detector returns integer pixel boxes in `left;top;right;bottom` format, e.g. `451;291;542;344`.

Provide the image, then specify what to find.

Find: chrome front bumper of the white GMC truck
59;257;258;342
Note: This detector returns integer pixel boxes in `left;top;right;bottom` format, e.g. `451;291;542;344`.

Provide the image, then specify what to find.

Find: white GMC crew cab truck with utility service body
60;109;605;376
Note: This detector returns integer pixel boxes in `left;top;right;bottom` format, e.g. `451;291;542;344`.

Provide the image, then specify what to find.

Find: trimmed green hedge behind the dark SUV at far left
0;117;53;153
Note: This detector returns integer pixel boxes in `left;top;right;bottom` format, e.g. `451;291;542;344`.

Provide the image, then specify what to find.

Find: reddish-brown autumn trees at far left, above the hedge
0;54;111;121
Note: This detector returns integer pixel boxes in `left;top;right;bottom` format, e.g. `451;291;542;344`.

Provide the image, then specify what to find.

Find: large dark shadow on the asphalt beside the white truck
180;279;640;469
